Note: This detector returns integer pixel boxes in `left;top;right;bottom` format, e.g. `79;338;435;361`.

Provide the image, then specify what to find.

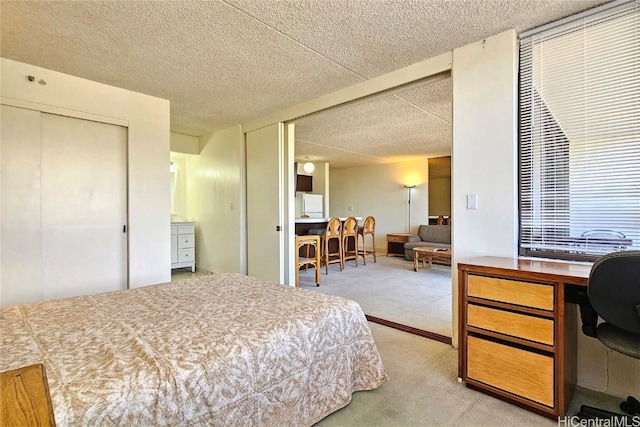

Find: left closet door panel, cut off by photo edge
0;105;42;305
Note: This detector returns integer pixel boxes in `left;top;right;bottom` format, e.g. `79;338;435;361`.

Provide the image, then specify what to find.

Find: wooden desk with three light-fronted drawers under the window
458;257;591;419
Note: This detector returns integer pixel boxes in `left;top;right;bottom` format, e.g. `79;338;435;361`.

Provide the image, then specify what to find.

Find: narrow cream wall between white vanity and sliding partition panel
187;125;244;273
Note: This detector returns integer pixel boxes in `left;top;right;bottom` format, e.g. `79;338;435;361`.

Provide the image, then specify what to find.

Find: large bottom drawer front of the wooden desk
467;337;554;408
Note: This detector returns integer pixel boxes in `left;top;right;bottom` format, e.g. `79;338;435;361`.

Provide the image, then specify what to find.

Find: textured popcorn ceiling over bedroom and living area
0;0;607;167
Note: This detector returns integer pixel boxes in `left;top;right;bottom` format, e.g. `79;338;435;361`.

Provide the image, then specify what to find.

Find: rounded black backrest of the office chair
588;251;640;334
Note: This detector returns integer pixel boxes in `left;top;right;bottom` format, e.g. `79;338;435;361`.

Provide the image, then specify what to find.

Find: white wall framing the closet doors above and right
0;58;171;288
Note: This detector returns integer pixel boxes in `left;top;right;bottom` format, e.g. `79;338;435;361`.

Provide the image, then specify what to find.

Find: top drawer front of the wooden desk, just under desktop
467;274;553;311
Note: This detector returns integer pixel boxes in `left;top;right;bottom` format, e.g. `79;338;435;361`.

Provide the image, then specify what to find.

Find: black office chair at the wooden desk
578;251;640;419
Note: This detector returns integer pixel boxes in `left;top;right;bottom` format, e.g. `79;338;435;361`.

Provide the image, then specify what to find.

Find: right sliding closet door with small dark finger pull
41;113;127;299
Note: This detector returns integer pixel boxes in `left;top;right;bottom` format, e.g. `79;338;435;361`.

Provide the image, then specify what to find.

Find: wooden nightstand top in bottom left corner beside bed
0;364;56;426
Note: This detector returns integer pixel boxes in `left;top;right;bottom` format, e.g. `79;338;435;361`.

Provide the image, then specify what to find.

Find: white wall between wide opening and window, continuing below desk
452;31;640;397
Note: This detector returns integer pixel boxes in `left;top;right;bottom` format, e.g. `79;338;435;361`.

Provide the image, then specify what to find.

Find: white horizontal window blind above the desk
520;0;640;260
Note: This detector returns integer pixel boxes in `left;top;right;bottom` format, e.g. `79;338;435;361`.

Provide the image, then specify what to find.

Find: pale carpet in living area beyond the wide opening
300;255;452;337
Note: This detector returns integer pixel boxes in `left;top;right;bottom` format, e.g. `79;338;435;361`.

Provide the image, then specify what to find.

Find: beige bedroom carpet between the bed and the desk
316;322;618;427
